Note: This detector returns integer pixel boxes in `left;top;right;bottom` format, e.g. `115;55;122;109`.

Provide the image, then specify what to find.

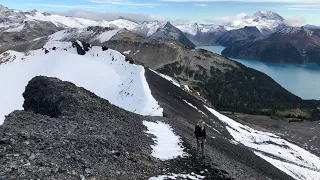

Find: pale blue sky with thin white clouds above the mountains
0;0;320;25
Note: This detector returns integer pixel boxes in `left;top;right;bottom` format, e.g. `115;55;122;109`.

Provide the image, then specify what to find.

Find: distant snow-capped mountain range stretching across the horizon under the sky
0;5;320;63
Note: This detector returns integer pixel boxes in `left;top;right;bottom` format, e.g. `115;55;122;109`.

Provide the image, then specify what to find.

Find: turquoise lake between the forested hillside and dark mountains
197;46;320;100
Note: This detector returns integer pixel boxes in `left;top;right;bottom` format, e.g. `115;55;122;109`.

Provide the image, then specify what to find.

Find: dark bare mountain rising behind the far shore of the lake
222;27;320;64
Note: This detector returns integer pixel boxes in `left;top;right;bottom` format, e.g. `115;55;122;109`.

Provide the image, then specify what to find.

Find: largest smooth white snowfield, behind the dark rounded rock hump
0;41;163;124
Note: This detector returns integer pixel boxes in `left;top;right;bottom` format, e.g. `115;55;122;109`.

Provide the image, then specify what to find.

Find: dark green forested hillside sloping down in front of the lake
205;66;320;119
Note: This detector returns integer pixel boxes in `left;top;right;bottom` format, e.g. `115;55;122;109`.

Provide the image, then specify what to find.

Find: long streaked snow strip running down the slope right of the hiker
205;106;320;180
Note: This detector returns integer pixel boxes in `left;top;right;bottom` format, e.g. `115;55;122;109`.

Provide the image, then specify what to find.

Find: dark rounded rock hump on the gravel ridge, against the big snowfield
23;77;110;117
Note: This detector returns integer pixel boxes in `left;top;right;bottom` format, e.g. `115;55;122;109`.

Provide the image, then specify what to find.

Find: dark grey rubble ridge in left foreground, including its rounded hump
0;77;232;180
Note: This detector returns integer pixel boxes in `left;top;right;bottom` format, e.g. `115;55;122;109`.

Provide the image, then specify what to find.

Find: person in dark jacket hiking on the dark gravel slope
194;119;207;157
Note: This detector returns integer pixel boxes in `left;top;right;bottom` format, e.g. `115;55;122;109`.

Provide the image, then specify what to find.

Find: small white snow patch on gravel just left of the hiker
143;121;186;160
